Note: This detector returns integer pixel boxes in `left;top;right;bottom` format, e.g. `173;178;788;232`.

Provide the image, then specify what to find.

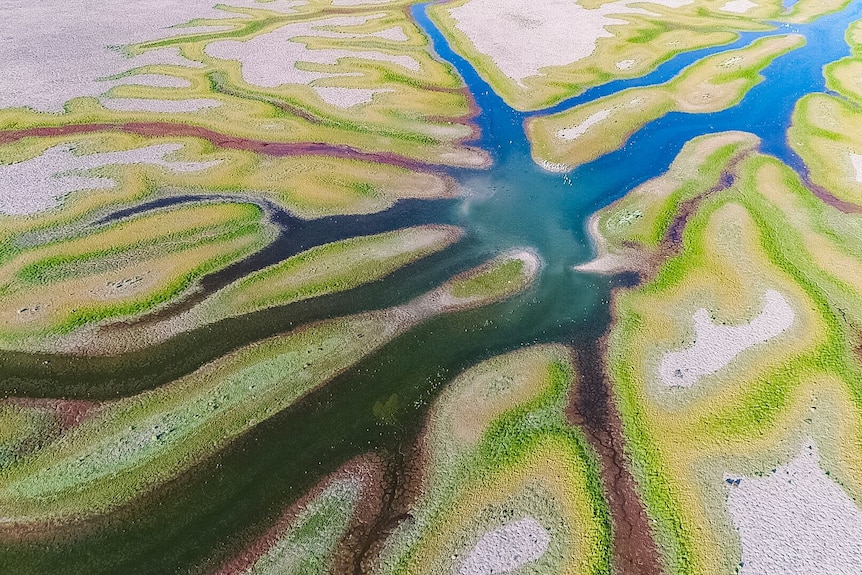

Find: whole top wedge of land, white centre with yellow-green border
429;0;783;110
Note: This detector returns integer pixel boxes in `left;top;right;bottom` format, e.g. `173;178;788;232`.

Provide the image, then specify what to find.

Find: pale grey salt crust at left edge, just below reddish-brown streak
0;144;220;215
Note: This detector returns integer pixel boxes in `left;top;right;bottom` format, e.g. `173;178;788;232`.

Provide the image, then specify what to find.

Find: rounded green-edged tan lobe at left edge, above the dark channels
0;203;275;347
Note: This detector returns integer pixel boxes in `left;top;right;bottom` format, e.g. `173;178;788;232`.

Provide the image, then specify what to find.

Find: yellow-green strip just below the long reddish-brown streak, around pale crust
0;132;460;227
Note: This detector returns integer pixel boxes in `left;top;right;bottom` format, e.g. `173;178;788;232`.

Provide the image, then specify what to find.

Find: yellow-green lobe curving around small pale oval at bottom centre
375;345;612;574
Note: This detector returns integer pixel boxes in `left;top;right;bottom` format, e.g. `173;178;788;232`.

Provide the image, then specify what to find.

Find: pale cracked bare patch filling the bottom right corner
725;440;862;575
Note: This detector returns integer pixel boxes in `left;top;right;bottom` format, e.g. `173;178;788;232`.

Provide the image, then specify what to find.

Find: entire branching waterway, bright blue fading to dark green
0;2;862;575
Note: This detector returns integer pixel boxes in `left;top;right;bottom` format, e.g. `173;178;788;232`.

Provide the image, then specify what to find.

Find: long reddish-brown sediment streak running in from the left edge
0;122;480;170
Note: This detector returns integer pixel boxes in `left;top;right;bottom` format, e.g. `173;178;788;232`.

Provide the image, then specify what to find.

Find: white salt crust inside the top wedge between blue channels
449;0;693;87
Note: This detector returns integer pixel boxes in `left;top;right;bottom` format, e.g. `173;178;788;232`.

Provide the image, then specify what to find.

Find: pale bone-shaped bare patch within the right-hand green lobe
659;290;796;387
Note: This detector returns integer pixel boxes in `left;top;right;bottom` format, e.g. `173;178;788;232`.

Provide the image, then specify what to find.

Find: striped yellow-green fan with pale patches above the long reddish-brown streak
0;4;487;166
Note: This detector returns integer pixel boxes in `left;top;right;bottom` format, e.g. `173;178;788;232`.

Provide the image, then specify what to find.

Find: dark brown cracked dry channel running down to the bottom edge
566;338;663;575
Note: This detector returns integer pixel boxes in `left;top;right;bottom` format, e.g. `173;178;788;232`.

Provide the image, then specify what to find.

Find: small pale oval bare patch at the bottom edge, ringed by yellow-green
458;517;551;575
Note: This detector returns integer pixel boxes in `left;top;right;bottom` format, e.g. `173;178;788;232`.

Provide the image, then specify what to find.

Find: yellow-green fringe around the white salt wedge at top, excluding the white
429;0;788;111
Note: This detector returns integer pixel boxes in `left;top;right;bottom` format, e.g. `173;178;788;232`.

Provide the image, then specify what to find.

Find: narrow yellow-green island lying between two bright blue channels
526;34;805;171
